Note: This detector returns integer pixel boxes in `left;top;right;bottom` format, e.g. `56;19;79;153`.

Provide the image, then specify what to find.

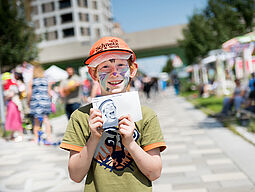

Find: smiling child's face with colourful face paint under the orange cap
97;59;130;95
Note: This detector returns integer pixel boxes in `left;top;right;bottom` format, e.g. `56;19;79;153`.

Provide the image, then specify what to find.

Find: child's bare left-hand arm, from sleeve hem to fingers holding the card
68;108;103;183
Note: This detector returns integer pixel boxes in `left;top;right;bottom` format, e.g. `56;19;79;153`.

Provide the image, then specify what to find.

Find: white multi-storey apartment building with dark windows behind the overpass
29;0;113;49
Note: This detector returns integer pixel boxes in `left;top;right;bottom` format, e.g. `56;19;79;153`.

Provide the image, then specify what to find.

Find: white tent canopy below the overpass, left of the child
44;65;68;82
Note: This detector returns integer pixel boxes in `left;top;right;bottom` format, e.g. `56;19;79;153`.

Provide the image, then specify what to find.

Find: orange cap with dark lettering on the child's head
84;37;135;65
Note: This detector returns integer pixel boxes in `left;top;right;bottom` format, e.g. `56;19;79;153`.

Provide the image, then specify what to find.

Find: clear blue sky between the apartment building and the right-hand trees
112;0;207;33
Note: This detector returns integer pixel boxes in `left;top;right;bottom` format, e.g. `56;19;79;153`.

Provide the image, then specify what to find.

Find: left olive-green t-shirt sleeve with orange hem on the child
60;110;89;152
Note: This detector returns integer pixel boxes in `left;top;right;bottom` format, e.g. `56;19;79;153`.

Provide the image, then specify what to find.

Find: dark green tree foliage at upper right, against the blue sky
179;0;255;64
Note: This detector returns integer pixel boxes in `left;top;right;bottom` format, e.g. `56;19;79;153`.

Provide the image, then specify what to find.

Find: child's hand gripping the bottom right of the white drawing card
119;115;135;146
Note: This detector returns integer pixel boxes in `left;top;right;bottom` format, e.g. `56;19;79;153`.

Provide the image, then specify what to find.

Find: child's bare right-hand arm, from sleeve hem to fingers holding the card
119;115;162;181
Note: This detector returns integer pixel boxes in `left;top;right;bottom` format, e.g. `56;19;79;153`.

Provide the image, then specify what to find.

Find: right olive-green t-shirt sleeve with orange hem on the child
141;106;166;151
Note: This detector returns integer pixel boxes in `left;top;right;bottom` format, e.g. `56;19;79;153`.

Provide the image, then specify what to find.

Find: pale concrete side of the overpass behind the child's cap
39;25;186;63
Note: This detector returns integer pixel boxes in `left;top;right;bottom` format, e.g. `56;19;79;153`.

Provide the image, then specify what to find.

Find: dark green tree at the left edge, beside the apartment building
0;0;38;71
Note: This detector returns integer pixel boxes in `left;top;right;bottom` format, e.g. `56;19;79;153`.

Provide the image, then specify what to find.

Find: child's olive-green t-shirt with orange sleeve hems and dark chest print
60;104;166;192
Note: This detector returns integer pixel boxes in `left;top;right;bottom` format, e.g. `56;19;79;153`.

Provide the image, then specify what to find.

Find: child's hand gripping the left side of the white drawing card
89;108;103;139
